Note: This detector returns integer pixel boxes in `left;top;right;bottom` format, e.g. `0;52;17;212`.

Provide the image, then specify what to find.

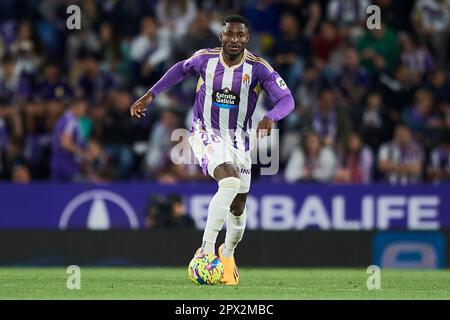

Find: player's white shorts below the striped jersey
189;130;252;193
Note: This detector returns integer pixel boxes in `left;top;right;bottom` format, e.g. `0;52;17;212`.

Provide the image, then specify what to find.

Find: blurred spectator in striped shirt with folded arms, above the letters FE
378;124;424;185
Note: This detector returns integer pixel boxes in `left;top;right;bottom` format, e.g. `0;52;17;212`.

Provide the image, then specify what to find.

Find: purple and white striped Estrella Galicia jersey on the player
150;48;293;150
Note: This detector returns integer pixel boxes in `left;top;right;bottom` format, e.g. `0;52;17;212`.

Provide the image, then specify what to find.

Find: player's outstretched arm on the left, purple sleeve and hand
130;50;202;118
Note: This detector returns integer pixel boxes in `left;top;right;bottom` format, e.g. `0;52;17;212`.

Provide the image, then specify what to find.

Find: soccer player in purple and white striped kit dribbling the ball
130;15;294;285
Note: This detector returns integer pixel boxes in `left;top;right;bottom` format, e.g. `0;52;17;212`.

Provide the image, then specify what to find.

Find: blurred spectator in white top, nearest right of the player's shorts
284;132;337;183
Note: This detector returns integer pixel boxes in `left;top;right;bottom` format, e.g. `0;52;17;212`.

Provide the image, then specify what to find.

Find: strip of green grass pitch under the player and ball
0;267;450;300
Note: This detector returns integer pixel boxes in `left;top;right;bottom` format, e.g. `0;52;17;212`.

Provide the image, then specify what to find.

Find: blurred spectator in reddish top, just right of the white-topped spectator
334;133;373;183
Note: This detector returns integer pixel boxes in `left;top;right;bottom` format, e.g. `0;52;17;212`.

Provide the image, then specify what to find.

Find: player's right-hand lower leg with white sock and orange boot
218;193;247;285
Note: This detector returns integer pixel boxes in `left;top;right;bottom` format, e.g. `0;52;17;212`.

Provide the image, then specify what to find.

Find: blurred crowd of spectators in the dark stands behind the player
0;0;450;184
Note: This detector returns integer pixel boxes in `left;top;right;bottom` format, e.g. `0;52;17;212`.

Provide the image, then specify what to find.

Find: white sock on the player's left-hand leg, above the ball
202;177;241;254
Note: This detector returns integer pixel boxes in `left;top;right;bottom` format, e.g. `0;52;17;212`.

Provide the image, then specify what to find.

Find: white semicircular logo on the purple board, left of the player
59;190;139;230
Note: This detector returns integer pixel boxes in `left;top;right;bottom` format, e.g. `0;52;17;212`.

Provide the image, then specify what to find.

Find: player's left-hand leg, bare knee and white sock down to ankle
201;163;241;254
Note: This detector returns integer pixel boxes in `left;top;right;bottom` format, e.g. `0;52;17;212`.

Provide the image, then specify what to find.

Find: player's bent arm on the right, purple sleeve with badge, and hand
256;65;295;137
